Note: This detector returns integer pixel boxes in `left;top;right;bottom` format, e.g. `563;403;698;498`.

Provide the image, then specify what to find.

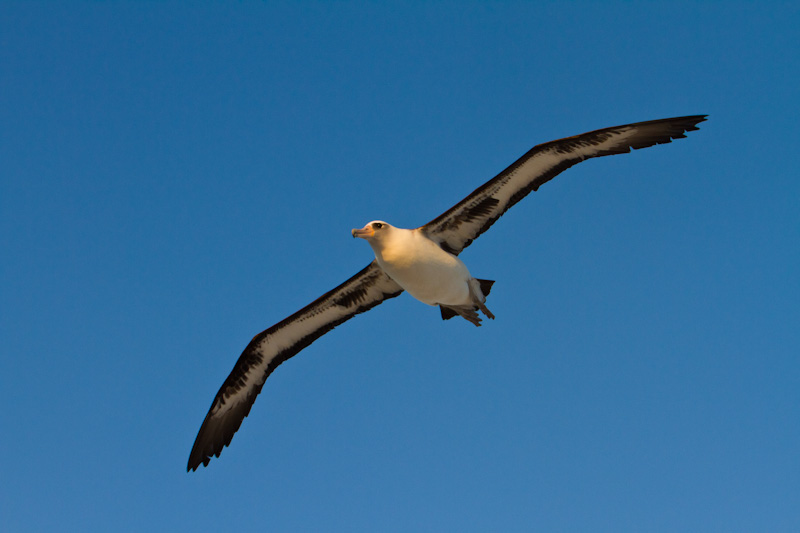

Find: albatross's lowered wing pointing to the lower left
186;261;403;471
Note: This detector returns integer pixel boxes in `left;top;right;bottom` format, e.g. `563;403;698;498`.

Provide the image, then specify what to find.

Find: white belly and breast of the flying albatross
375;232;471;305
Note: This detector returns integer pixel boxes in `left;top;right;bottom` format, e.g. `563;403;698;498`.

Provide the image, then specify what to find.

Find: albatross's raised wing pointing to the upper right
421;115;707;255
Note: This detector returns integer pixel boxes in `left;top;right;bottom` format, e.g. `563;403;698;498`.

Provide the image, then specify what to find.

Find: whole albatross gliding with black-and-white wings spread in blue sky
187;115;707;471
